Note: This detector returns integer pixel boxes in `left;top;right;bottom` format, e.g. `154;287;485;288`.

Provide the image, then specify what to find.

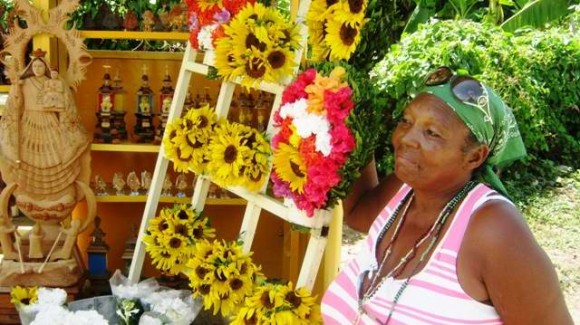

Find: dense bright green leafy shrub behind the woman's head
371;17;580;175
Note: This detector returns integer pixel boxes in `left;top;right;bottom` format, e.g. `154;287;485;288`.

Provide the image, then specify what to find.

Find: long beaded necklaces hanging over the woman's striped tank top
355;181;477;324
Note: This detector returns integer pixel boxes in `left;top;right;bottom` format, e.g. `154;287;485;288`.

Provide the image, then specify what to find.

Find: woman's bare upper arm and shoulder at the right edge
467;201;573;325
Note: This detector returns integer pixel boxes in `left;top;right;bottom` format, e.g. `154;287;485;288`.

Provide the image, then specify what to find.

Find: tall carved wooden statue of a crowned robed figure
0;0;96;286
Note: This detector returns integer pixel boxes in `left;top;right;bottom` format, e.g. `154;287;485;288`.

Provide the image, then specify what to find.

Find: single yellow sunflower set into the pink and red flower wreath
273;143;307;194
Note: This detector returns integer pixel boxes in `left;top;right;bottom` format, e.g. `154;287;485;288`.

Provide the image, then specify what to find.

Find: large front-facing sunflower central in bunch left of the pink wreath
207;122;249;186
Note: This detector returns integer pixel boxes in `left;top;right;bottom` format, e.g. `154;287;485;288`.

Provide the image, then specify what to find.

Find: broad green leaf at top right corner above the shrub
501;0;570;32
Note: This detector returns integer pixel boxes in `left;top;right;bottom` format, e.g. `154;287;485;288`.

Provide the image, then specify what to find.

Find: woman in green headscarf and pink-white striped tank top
322;68;572;324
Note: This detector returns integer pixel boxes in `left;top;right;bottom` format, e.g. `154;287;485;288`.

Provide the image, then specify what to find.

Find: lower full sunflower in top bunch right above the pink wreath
326;19;362;61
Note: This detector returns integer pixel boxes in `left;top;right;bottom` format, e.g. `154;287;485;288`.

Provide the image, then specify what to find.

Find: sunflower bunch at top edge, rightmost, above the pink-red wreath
306;0;368;62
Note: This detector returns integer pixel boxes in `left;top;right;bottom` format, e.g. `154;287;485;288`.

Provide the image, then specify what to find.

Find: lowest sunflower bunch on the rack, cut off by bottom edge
231;282;322;325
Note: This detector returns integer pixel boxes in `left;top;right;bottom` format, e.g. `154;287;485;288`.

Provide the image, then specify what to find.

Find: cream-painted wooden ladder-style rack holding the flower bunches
129;1;336;290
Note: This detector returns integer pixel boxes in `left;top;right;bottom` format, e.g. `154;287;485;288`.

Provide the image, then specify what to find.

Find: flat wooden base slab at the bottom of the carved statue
0;259;83;288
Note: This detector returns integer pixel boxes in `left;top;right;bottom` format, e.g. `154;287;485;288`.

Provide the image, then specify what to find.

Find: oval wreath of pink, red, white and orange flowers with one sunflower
271;67;356;216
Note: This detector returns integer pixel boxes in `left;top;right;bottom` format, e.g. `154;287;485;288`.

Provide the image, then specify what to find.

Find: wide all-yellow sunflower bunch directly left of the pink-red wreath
163;105;271;191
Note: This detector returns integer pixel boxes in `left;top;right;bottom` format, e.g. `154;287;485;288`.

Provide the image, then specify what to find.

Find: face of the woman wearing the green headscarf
393;94;471;189
